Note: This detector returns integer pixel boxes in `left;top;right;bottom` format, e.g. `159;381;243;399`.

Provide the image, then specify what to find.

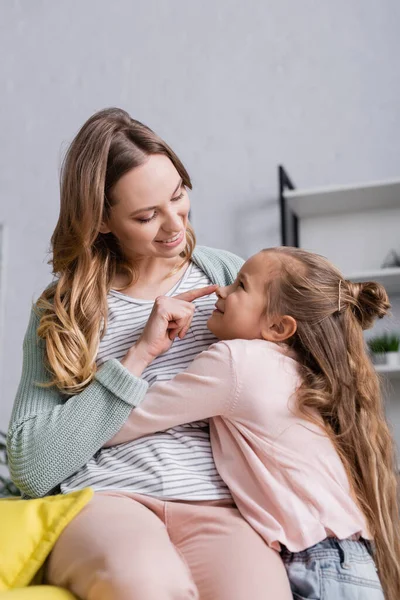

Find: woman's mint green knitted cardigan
7;246;243;498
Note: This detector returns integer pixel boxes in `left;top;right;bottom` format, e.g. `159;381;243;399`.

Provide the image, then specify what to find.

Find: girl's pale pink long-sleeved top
106;340;369;552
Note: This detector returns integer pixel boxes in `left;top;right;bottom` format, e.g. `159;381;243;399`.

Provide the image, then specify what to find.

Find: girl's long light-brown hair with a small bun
263;247;400;600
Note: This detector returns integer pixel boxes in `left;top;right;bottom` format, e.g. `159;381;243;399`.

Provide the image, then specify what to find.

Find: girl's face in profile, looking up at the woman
207;252;271;340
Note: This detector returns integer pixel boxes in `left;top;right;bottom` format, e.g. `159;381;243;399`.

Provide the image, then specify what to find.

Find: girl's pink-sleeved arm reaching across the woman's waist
104;342;237;447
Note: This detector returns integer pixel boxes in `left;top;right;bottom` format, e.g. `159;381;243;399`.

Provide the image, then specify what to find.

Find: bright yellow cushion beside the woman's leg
0;488;93;600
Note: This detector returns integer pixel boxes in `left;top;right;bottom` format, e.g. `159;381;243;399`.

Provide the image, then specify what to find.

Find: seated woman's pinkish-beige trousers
46;492;292;600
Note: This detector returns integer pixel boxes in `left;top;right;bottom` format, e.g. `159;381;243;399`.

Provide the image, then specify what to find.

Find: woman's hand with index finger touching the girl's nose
121;285;218;376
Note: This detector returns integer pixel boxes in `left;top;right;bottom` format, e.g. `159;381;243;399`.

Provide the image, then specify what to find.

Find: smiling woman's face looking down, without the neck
101;154;190;259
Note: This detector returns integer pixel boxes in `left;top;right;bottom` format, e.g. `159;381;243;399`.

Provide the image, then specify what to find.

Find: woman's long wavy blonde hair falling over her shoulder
36;108;196;395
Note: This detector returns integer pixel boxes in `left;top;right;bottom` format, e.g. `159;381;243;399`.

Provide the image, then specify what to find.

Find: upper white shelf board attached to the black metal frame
285;180;400;218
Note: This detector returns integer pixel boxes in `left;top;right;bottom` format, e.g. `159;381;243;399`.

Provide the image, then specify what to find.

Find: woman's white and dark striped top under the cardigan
61;262;230;501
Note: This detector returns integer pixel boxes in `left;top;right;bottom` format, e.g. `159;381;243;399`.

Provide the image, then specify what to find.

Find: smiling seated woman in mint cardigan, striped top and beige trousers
8;108;291;600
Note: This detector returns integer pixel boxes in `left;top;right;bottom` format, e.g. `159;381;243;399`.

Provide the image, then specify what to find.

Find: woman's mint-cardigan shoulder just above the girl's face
192;246;244;285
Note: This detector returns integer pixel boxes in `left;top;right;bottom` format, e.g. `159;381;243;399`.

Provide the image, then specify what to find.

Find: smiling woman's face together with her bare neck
100;154;193;299
